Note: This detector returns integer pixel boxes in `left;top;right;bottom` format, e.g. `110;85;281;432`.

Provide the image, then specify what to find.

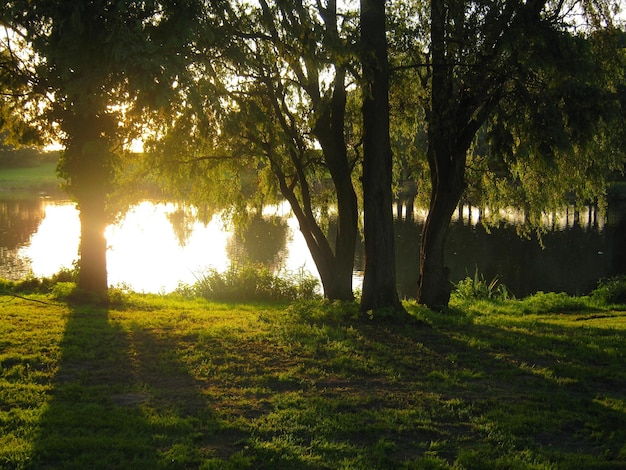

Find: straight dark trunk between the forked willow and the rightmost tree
361;0;404;312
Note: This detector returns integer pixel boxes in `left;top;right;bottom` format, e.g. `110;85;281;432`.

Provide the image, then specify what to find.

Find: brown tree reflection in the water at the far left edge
0;198;45;279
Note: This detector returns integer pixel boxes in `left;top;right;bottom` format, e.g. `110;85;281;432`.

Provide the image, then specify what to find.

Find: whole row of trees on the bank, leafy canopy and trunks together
0;0;626;310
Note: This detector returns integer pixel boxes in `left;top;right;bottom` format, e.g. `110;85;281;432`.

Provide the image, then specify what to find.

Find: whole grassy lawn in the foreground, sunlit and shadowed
0;294;626;470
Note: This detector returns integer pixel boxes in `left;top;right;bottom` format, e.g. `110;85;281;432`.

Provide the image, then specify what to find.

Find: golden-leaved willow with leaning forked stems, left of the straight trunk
147;0;358;300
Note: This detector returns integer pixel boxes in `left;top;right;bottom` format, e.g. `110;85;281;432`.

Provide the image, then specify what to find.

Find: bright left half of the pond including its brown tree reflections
8;200;315;292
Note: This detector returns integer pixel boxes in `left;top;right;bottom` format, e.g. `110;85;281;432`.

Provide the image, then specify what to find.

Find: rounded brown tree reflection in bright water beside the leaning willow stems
226;214;291;271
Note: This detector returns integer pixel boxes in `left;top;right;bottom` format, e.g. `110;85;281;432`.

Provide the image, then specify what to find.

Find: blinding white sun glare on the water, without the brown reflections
18;201;316;292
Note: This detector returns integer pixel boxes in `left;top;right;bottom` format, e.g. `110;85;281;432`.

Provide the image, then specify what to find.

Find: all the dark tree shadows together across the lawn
31;307;626;469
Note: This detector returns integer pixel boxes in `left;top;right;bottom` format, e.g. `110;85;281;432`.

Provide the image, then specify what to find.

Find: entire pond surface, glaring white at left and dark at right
0;198;626;297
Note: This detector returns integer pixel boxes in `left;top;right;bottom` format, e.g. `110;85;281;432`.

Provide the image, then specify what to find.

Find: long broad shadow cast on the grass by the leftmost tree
29;307;224;469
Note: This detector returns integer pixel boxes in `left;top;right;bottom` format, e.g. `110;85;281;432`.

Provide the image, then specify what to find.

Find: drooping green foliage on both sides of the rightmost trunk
389;1;626;224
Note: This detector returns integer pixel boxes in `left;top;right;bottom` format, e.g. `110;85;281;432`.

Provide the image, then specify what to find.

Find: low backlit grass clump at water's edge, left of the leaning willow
177;264;319;302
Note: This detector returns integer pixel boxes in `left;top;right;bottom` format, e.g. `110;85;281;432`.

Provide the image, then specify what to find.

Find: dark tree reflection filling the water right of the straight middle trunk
395;207;626;297
